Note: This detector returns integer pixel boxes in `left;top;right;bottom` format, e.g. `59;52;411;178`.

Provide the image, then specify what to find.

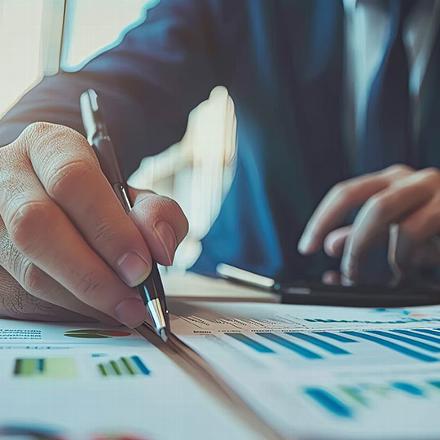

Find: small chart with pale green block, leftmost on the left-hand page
13;358;77;379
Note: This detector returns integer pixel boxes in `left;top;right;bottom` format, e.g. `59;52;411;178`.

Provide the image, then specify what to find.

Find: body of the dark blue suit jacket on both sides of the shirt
195;0;440;278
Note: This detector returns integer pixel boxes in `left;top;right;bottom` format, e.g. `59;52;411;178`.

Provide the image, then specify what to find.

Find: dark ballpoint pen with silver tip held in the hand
80;89;169;342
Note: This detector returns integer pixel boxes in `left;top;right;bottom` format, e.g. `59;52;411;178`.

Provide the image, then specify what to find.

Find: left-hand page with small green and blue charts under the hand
0;320;258;440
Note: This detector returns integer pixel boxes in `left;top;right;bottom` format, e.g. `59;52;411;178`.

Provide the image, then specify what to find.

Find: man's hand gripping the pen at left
0;111;187;327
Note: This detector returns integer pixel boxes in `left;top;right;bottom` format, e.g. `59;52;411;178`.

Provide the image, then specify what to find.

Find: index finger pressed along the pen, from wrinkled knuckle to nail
28;124;151;287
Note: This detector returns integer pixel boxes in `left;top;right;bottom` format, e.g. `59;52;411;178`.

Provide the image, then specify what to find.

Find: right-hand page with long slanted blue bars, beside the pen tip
171;302;440;439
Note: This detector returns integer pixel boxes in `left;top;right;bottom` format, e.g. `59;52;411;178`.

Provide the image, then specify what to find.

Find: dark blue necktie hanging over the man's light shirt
358;0;416;173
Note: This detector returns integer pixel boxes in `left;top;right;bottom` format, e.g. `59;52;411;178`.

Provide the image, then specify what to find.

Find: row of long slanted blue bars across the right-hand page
225;328;440;363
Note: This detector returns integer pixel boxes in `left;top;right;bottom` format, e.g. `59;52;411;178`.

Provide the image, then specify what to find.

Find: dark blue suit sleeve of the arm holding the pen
0;0;221;176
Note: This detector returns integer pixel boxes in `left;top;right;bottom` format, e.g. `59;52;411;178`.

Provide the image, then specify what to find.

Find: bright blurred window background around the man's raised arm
0;0;236;271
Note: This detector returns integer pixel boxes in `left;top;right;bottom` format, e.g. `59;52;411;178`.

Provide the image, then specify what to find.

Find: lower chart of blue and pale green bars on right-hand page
302;376;440;419
